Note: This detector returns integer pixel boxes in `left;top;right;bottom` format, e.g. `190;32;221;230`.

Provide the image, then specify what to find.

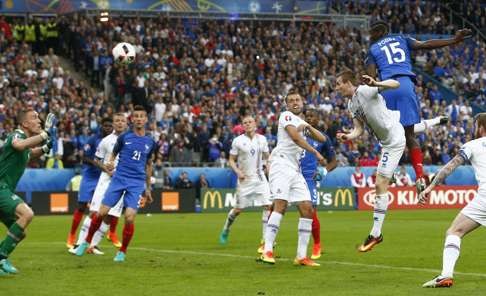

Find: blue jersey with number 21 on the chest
113;131;156;181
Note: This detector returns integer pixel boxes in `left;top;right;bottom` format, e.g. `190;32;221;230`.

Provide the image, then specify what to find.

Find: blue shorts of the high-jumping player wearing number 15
381;76;420;126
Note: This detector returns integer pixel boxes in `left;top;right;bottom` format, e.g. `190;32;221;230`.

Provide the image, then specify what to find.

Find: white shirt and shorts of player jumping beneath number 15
348;85;406;178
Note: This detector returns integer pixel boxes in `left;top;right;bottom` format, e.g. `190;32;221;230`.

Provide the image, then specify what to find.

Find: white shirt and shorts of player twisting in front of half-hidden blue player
270;111;311;202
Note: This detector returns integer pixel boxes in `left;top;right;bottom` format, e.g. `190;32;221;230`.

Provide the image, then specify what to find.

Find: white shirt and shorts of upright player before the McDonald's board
230;134;271;209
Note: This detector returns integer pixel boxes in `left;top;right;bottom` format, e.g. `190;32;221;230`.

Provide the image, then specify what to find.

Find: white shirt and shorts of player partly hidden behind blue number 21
89;133;123;217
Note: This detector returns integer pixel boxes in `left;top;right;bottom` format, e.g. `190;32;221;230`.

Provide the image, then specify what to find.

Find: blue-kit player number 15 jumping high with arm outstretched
366;21;471;193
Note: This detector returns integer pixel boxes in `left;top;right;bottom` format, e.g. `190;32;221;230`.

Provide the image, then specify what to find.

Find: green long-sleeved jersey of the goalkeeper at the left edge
0;129;30;192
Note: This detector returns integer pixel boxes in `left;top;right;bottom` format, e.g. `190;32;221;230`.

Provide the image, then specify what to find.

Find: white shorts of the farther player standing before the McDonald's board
235;177;272;209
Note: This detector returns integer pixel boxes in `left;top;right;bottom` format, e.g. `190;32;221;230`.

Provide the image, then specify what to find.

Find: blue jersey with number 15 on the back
366;35;415;81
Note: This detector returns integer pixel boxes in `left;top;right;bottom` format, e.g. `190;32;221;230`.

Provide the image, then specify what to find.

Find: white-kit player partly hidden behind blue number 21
69;113;127;255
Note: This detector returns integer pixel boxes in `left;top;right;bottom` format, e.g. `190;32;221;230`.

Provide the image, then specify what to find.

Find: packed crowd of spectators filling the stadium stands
0;2;486;171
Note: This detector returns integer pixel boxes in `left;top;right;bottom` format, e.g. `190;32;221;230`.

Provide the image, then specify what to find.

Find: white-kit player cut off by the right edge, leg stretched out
419;113;486;288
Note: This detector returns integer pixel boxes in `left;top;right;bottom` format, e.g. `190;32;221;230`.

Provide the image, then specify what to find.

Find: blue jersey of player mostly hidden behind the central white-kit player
300;134;335;179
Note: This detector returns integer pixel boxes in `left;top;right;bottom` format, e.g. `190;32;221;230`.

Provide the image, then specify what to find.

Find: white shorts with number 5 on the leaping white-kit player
376;134;406;179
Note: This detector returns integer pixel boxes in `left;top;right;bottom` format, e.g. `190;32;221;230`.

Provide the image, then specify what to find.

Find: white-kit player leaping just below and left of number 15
336;70;406;252
